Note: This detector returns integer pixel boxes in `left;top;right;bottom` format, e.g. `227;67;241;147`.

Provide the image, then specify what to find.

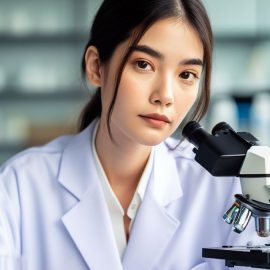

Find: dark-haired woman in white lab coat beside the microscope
0;0;260;270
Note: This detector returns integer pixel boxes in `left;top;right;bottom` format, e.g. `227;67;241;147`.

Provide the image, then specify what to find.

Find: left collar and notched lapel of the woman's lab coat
59;124;122;270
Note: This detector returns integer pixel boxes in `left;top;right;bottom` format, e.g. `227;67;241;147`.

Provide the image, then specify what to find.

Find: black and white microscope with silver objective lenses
182;121;270;269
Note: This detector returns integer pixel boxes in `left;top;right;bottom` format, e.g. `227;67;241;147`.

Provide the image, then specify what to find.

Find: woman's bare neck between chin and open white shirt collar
95;118;151;188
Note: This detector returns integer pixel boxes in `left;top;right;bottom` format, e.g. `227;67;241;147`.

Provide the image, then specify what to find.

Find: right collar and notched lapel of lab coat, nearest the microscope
123;142;182;270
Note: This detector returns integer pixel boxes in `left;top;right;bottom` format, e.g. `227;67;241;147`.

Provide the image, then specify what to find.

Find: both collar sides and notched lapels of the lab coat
59;123;182;270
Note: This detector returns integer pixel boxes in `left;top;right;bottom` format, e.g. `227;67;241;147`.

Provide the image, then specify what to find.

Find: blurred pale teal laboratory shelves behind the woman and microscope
0;0;270;164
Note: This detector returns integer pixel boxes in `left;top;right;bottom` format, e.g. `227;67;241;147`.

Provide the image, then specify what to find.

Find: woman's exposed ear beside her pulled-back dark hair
85;46;101;87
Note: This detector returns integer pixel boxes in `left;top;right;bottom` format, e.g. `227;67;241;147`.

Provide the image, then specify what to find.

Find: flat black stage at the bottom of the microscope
202;245;270;269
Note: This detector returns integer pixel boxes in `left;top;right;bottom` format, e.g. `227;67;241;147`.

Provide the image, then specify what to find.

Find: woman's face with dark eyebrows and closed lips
101;19;203;146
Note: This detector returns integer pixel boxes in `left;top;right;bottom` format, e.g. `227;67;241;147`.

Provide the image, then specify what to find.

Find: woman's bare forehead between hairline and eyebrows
138;18;204;59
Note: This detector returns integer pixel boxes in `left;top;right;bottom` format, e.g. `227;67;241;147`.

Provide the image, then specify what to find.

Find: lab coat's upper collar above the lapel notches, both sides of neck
58;120;182;206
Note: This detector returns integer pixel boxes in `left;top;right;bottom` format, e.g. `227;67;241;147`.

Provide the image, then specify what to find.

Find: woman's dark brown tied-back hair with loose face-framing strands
79;0;213;137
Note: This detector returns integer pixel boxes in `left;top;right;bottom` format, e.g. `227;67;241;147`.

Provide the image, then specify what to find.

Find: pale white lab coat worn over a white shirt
0;119;264;270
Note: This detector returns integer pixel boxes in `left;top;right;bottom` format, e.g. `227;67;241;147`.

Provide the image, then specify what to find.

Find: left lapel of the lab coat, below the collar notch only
62;186;122;270
